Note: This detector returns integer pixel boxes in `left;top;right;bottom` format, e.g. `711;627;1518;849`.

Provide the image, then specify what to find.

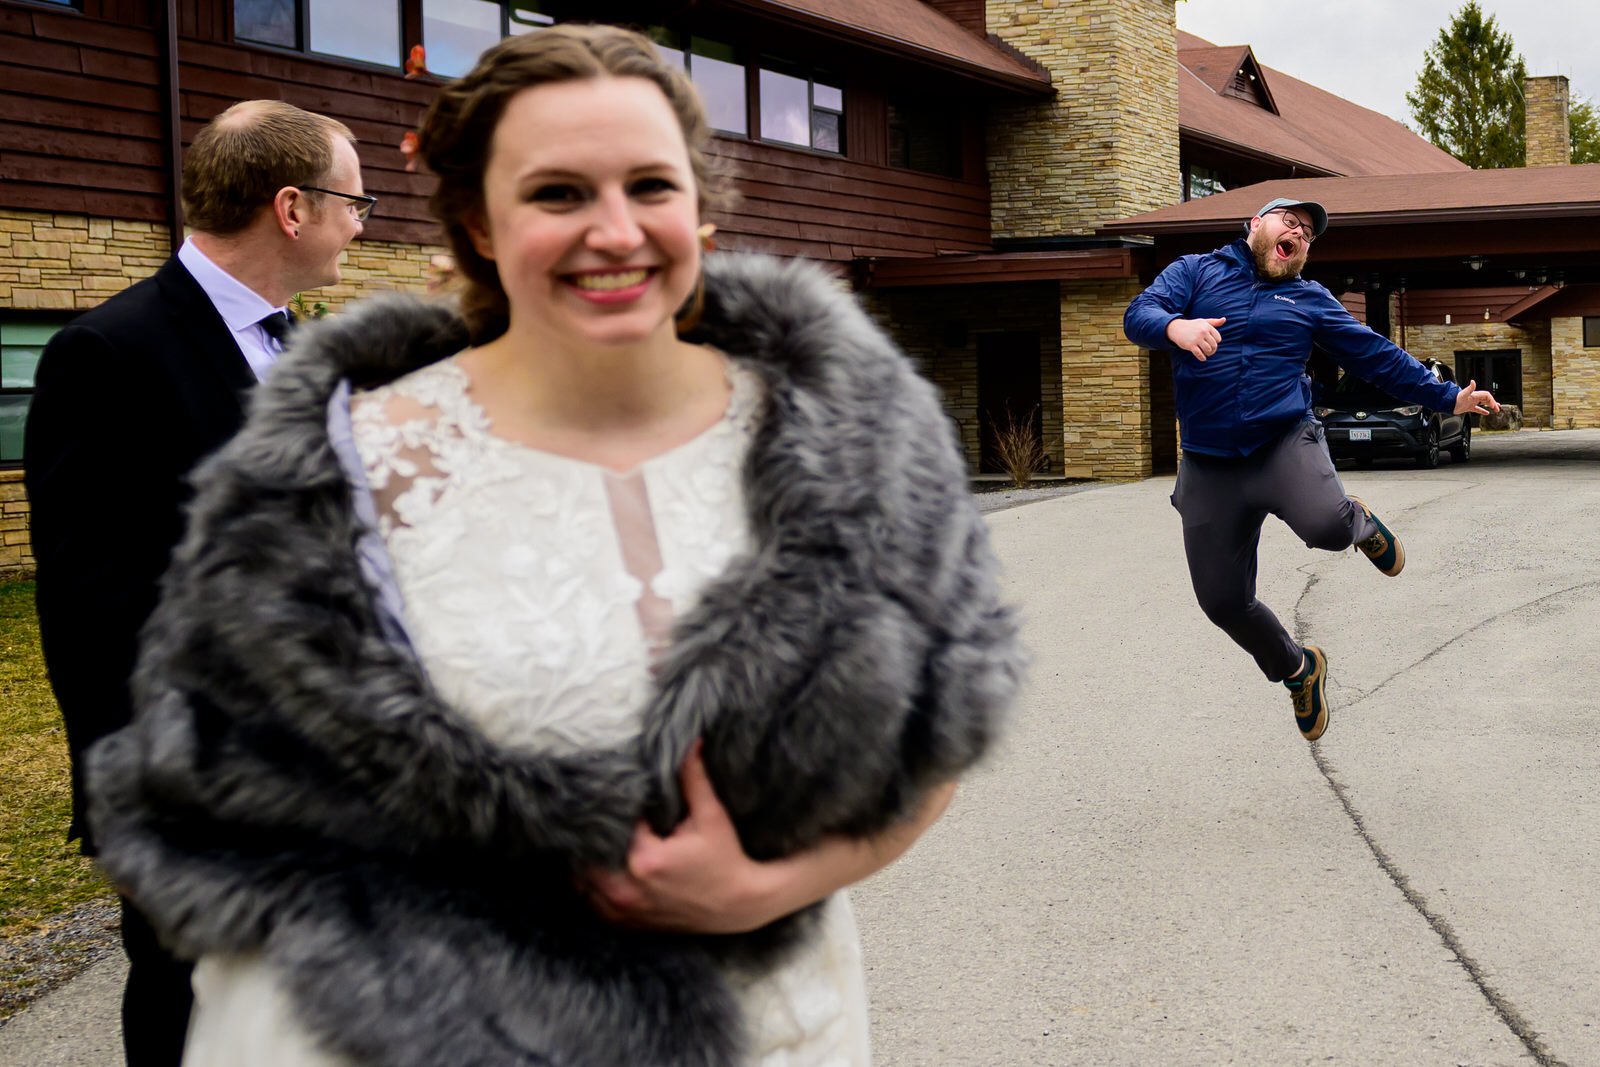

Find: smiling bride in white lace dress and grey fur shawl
91;26;1021;1067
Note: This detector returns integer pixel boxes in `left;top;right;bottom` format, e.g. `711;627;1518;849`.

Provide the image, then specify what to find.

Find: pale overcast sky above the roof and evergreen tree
1178;0;1600;126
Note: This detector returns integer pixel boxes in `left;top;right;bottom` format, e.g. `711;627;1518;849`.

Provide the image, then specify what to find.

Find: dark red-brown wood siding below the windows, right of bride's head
712;138;989;261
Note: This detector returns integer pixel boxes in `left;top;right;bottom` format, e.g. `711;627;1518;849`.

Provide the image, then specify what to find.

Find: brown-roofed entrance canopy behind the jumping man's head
1099;163;1600;293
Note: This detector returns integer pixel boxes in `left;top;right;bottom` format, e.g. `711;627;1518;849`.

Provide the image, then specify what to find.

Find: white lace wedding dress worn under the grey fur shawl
184;360;869;1067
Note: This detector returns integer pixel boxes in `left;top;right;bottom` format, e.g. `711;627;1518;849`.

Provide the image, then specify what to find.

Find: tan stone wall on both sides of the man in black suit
0;210;445;579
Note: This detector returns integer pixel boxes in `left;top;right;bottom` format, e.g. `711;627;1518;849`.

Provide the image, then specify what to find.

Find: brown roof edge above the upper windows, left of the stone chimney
725;0;1053;94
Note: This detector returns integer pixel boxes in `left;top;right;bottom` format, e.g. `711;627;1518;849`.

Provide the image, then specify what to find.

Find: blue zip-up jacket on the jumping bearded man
1122;238;1461;456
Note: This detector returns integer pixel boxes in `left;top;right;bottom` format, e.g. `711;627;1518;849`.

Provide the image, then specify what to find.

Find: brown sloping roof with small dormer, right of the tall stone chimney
1178;30;1467;174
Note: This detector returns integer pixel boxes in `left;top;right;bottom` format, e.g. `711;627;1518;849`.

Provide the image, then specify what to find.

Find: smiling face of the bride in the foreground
469;77;699;347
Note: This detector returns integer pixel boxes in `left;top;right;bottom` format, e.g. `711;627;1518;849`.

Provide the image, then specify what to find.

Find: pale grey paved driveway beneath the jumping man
0;430;1600;1067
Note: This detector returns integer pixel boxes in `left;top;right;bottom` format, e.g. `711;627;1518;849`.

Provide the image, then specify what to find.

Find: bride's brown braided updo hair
418;24;722;344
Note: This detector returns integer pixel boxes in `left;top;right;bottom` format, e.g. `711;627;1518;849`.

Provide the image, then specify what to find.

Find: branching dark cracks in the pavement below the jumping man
1294;547;1580;1067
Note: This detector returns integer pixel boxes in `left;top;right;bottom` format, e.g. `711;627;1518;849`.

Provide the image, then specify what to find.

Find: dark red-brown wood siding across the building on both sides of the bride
0;0;990;255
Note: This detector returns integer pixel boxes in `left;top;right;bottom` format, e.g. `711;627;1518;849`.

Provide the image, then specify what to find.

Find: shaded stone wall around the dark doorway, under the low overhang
862;282;1062;474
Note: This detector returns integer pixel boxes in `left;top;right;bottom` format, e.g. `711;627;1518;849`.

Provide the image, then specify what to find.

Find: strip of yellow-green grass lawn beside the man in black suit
0;582;112;1017
